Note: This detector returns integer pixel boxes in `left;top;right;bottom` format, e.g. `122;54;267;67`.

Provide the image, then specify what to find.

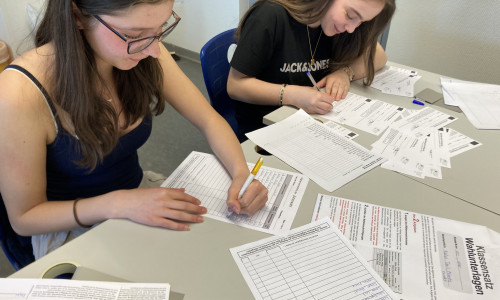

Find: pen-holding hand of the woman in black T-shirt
283;85;335;115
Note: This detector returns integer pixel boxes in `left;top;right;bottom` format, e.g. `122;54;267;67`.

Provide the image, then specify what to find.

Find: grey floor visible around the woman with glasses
0;57;212;278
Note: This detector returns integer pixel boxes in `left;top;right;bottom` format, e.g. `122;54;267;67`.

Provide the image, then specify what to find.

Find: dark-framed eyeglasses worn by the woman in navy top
93;11;181;54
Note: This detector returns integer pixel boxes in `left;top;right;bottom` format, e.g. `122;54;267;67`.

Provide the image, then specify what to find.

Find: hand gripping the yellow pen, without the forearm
226;177;268;216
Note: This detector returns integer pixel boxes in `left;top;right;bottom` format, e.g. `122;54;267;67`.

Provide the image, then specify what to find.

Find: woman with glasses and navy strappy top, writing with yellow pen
0;0;267;258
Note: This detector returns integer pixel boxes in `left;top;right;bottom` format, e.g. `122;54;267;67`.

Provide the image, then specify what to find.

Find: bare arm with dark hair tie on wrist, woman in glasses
0;62;206;236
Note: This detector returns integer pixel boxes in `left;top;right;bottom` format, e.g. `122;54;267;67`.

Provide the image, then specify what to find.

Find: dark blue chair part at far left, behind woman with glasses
0;195;35;270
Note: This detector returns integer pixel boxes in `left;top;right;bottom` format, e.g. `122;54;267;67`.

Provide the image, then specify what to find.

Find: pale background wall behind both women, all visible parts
0;0;500;84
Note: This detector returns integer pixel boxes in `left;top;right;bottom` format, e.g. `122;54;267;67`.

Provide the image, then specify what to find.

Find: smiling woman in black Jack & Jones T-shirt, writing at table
227;0;395;140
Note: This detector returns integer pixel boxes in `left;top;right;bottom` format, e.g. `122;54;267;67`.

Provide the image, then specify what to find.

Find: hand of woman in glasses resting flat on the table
116;187;207;230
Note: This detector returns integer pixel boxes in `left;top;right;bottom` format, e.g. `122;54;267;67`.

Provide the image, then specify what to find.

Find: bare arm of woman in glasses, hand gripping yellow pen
159;46;267;214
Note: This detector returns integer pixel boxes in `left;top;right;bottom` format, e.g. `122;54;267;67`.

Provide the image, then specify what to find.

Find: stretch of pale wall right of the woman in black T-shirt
386;0;500;84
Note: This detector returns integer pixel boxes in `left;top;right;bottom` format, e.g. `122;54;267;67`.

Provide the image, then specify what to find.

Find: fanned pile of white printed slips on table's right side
371;107;482;179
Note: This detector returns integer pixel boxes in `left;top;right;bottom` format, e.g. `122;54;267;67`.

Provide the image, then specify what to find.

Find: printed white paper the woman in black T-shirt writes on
317;93;405;135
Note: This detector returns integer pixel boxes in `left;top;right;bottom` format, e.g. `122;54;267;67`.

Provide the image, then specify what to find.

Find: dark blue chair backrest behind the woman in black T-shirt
200;28;238;132
